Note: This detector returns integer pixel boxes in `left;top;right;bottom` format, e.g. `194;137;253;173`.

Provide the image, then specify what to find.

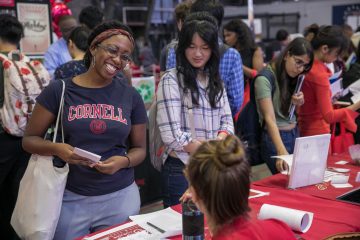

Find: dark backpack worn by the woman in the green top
235;68;275;166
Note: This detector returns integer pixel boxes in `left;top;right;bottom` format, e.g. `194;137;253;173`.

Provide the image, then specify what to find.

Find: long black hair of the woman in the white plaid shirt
176;13;224;108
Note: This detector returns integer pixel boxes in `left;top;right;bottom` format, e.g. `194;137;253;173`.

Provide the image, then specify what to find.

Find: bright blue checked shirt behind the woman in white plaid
166;41;244;116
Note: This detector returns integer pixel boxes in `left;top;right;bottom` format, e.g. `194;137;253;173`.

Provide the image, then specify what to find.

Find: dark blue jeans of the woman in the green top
261;127;299;174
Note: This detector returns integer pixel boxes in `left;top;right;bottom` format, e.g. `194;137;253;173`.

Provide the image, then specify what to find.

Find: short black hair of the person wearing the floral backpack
0;14;24;45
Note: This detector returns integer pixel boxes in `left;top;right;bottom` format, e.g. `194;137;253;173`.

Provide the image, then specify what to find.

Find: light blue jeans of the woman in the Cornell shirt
54;182;140;240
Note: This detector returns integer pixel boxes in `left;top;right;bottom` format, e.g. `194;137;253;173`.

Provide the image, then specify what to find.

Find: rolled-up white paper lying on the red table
258;204;314;233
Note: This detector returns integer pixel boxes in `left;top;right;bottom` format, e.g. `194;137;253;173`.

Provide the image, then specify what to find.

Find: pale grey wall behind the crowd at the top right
225;0;360;32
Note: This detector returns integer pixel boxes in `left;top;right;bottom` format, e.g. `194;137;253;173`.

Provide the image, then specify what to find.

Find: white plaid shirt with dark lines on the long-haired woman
155;69;234;164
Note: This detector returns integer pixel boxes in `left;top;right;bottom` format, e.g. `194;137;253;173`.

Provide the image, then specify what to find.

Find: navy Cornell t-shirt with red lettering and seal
37;78;147;196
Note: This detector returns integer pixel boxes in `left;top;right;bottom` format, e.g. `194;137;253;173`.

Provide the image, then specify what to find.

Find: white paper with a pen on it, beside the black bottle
129;208;182;238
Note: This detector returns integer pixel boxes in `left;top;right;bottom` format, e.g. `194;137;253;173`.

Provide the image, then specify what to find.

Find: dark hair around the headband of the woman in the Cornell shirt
84;21;133;68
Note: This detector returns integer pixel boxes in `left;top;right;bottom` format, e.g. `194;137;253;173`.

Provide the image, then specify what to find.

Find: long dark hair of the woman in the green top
272;37;314;116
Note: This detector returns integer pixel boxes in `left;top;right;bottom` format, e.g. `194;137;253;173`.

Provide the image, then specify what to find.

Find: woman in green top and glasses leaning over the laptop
255;38;314;174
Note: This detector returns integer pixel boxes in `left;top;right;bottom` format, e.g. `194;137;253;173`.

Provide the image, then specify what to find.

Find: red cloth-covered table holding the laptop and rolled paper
78;155;360;240
